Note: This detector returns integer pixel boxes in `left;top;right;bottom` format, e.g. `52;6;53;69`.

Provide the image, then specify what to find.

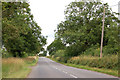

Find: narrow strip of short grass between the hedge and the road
47;57;118;77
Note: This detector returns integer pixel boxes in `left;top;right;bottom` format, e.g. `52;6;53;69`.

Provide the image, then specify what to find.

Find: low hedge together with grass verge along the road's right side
48;55;118;76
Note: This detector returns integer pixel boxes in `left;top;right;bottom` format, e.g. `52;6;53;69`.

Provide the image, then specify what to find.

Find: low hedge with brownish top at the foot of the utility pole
67;55;118;70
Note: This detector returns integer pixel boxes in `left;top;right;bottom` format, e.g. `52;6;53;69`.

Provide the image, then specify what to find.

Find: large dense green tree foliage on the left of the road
2;2;46;57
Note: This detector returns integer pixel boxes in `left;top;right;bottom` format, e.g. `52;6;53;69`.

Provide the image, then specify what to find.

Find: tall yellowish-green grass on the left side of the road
2;57;38;78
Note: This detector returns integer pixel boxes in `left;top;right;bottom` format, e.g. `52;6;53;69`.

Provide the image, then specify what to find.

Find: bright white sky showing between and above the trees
29;0;120;46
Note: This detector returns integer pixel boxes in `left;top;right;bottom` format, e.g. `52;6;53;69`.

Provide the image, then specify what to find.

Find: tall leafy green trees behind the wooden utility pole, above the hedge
48;1;120;57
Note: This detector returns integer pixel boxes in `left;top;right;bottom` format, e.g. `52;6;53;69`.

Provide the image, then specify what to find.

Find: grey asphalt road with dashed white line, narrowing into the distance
28;57;116;78
